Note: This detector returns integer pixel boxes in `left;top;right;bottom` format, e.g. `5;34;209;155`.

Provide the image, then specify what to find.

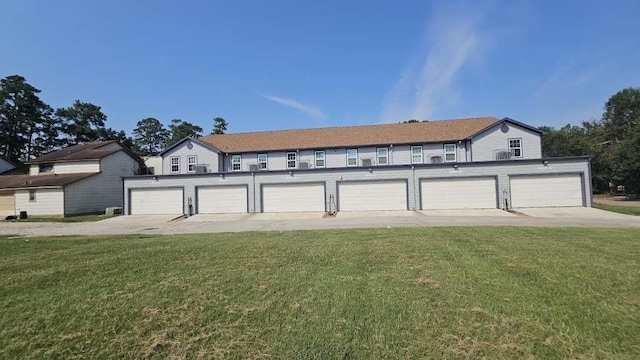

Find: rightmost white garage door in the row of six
510;174;583;208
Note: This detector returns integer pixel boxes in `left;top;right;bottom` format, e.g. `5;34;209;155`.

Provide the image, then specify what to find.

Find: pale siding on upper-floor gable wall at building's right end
471;123;542;161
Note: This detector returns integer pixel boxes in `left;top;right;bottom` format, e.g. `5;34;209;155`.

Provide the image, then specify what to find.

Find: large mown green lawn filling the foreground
0;227;640;359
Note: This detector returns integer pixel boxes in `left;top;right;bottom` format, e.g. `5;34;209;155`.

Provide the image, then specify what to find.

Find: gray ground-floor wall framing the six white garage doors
124;157;591;213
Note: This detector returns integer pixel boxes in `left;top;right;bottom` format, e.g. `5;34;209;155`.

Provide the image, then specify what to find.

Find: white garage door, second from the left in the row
198;186;247;214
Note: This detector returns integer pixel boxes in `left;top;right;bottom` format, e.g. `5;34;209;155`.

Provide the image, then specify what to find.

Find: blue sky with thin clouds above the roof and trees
0;0;640;132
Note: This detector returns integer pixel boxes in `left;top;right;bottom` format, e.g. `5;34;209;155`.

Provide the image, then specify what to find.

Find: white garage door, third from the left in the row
262;183;325;212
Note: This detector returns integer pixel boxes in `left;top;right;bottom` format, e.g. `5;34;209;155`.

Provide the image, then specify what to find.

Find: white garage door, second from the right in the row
420;177;498;210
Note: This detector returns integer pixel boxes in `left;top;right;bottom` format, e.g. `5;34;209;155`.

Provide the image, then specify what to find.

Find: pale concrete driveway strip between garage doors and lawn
0;208;640;236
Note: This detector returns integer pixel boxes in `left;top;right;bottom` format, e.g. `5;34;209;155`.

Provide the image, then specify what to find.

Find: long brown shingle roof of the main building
200;117;498;153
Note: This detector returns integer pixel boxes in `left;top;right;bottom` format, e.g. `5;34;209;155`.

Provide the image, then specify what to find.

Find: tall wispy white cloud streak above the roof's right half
381;5;483;122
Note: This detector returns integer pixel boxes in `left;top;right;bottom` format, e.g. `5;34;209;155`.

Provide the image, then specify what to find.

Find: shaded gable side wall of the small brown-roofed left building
65;151;139;215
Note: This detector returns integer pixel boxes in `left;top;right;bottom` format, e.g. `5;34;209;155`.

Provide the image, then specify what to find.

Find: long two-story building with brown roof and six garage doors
125;117;591;214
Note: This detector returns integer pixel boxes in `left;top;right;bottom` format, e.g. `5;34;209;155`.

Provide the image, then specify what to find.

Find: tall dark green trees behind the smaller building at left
0;75;228;165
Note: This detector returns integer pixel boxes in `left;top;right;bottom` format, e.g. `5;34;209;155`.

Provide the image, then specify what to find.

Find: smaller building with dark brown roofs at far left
0;141;142;216
